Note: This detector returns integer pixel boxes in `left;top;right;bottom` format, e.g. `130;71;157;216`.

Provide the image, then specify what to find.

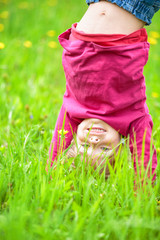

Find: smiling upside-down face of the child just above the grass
77;118;121;161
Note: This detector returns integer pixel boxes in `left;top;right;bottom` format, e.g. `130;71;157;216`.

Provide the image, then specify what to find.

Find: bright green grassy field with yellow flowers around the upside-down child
0;0;160;240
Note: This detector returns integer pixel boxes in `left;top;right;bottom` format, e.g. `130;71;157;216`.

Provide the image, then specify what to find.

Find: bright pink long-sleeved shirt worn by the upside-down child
50;26;157;180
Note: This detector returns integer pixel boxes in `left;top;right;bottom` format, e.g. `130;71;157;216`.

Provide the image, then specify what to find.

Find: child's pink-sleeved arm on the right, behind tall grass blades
129;115;157;185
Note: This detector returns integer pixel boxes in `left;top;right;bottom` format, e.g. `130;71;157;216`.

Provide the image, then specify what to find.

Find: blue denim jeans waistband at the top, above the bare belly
86;0;160;25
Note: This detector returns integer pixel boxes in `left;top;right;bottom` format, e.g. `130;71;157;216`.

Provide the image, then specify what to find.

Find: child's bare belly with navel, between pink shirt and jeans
77;1;145;34
